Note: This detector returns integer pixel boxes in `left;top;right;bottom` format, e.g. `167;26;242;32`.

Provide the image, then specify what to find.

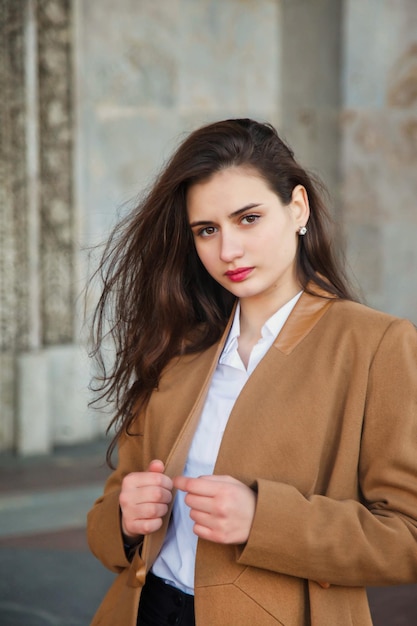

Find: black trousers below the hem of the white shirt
136;572;195;626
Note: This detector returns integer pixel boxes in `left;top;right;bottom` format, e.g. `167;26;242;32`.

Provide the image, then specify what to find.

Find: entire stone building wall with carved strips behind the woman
0;0;417;454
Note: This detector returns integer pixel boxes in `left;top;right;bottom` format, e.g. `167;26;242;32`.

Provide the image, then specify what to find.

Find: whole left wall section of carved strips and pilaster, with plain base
0;0;94;454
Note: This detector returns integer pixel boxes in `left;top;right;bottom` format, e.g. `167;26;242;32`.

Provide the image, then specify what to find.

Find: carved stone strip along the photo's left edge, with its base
0;0;29;449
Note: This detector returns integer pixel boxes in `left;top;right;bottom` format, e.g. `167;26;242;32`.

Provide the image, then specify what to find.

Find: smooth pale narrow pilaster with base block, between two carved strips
15;0;52;454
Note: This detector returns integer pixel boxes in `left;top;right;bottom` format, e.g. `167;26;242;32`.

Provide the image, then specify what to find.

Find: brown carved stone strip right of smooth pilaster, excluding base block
37;0;75;345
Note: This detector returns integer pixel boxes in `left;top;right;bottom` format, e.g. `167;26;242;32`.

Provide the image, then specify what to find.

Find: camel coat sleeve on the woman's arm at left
87;434;142;573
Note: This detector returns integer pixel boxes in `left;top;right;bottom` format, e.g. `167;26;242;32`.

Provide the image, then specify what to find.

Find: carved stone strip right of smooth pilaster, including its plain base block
36;0;94;444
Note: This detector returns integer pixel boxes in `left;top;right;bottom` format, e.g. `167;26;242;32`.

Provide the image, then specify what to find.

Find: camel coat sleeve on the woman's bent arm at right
238;320;417;586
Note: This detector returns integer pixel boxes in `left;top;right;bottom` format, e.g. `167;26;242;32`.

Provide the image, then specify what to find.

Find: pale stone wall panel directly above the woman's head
178;0;281;121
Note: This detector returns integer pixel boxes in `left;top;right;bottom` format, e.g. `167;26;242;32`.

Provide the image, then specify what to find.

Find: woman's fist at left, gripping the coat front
119;460;173;543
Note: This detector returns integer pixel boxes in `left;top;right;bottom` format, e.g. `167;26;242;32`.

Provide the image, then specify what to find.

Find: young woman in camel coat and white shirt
88;119;417;626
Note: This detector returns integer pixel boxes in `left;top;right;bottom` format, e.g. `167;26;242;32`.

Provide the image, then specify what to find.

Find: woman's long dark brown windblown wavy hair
88;119;355;462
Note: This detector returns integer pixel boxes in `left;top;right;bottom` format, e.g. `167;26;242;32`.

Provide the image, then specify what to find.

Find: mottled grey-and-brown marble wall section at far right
341;0;417;321
